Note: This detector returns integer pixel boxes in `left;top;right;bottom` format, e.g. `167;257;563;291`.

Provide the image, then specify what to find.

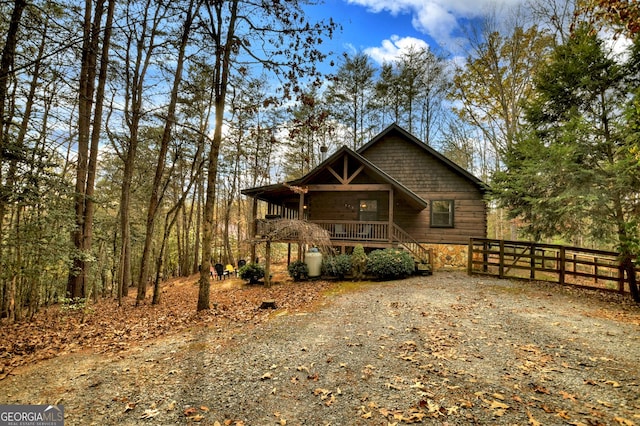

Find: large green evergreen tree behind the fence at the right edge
493;24;640;300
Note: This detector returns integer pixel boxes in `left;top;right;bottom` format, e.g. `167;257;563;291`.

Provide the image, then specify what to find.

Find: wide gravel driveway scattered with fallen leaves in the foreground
0;272;640;425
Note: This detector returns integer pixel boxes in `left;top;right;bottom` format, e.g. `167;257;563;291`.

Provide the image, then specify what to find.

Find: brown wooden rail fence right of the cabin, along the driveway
467;238;637;293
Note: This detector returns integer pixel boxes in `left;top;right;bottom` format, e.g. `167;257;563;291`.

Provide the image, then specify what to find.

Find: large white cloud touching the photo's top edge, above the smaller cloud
346;0;525;50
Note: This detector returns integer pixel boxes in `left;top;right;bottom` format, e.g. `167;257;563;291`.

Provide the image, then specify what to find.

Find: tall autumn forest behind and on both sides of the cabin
0;0;640;321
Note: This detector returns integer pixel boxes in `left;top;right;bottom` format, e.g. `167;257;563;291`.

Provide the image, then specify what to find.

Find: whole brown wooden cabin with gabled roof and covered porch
242;124;487;266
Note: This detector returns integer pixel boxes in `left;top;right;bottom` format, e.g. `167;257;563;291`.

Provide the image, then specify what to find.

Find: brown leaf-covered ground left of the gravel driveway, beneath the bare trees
0;267;328;380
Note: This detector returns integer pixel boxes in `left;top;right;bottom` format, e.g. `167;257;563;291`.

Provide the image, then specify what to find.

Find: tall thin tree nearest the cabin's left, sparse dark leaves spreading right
197;0;335;310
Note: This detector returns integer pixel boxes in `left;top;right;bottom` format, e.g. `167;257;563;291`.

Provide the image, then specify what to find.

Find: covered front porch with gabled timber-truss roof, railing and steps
242;147;436;261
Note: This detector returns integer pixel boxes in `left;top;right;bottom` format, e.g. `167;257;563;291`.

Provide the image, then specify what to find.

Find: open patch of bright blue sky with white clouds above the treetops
307;0;525;63
